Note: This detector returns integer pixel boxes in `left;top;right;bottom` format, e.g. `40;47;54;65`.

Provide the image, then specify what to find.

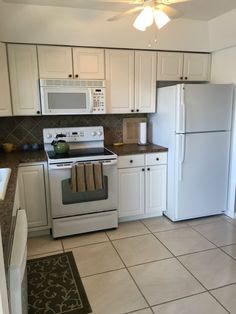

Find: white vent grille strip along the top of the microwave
40;79;105;87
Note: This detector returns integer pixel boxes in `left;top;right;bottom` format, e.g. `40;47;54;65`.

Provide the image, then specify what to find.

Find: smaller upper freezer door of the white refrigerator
176;84;233;133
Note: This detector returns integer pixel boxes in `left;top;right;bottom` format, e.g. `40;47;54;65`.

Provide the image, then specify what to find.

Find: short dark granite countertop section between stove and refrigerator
106;144;168;156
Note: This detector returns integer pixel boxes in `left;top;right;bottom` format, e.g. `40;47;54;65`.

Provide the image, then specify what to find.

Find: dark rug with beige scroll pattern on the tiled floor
27;252;92;314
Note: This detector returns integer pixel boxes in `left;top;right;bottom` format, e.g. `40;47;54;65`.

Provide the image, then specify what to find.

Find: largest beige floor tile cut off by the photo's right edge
179;249;236;289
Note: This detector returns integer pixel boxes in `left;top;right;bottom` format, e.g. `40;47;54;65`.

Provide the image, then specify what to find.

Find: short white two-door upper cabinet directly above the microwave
37;46;105;79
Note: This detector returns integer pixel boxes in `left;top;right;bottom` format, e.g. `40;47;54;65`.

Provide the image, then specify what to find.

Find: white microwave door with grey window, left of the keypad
40;87;93;115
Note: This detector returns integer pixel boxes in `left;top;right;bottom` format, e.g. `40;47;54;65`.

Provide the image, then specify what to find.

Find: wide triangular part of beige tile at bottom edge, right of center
153;293;227;314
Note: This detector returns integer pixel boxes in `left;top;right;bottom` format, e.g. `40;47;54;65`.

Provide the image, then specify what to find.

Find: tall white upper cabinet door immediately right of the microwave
106;49;134;113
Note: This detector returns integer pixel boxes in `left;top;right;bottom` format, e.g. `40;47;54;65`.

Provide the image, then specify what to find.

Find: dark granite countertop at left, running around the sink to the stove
0;150;47;266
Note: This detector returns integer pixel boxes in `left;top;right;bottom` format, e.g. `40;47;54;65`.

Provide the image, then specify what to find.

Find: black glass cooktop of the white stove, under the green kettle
47;147;114;159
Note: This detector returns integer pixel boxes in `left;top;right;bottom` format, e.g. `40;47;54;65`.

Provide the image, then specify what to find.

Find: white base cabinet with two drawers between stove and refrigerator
118;153;167;220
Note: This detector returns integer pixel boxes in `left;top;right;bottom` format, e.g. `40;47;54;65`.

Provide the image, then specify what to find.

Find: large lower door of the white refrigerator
175;132;230;220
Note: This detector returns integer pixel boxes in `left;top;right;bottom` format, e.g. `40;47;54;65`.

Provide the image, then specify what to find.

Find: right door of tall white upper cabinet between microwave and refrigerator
135;51;157;112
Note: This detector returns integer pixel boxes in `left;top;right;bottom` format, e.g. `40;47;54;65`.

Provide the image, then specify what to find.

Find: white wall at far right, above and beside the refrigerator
212;46;236;217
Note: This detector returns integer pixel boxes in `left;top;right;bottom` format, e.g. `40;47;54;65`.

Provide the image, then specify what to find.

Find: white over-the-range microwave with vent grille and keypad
40;79;106;115
